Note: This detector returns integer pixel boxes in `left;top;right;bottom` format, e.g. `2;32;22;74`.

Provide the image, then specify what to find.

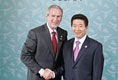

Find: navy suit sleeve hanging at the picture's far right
93;44;104;80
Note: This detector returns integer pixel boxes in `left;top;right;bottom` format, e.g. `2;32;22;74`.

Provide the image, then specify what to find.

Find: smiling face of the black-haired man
71;19;88;40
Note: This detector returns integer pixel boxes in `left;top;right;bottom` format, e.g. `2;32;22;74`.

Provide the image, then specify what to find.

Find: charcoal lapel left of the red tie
43;24;55;57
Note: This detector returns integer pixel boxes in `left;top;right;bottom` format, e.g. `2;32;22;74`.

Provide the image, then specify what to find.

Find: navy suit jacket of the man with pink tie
63;36;104;80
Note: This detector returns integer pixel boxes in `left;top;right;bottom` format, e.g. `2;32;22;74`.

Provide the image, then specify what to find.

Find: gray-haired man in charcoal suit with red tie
21;5;67;80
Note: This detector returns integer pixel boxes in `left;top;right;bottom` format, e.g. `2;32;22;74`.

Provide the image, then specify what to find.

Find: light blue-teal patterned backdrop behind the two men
0;0;118;80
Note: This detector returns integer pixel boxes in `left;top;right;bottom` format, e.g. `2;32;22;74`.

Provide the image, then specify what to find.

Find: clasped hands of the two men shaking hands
41;68;55;80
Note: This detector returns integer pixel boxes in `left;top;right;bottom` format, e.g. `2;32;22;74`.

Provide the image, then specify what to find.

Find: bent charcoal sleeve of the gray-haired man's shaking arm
21;30;41;74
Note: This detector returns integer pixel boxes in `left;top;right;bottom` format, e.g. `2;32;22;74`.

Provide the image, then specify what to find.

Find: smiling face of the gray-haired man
46;8;62;29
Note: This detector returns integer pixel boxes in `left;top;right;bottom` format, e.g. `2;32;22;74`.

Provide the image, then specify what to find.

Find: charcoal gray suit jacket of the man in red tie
21;24;67;80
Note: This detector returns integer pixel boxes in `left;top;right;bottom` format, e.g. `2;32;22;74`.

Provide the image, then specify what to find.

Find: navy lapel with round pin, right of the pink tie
73;36;89;66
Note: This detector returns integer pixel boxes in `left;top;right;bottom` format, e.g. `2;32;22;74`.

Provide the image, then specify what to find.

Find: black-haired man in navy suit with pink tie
63;14;104;80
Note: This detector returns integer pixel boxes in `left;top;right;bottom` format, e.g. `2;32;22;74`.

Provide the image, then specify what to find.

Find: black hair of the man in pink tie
71;14;88;27
